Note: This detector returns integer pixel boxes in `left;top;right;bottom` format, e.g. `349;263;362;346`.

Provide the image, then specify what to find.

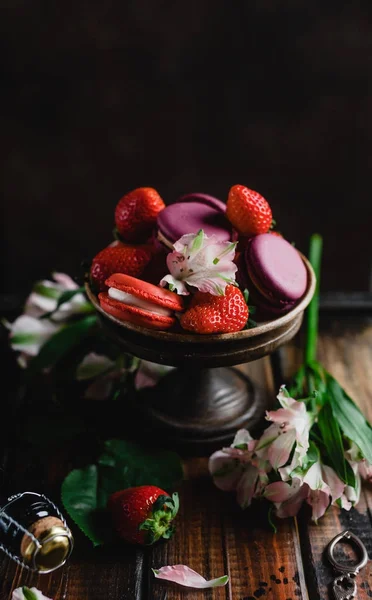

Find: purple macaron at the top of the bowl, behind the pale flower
157;193;233;248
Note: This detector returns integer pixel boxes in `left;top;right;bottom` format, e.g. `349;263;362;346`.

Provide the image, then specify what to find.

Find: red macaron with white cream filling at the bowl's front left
98;273;183;330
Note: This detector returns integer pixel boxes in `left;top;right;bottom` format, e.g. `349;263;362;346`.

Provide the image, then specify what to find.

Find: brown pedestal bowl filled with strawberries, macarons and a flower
85;185;316;444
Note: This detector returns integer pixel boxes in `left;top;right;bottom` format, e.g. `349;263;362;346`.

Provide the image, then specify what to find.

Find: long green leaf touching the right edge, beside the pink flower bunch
327;373;372;463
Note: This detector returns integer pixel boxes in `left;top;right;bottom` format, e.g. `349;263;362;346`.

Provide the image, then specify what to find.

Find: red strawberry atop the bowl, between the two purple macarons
226;185;273;236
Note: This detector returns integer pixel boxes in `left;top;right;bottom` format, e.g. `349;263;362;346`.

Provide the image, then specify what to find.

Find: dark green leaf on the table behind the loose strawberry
62;440;183;545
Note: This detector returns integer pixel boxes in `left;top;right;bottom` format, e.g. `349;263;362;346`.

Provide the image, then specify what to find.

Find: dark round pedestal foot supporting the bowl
137;367;266;454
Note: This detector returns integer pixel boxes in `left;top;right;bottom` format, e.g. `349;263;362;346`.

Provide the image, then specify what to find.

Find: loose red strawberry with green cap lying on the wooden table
108;485;179;545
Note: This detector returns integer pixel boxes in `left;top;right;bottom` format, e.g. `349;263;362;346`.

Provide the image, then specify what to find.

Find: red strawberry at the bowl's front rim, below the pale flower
180;285;249;333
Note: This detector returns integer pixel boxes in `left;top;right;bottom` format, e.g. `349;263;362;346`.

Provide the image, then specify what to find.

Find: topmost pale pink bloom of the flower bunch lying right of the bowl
256;386;313;480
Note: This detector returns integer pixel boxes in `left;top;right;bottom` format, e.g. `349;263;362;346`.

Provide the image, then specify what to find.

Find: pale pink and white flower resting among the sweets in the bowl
160;229;237;296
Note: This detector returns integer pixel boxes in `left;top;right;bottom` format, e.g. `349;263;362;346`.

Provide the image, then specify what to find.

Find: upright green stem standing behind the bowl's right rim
305;233;323;364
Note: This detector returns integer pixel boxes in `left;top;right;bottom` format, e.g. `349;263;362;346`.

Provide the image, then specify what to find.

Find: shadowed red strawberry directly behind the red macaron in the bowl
90;243;152;291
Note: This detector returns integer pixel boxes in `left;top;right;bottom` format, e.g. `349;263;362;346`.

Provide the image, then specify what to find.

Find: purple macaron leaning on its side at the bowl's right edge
241;233;307;318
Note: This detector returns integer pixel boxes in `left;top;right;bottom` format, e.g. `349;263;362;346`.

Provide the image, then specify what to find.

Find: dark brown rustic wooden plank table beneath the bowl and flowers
0;314;372;600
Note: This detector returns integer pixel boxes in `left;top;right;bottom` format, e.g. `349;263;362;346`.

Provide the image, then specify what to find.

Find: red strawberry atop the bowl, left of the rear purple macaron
115;188;165;242
